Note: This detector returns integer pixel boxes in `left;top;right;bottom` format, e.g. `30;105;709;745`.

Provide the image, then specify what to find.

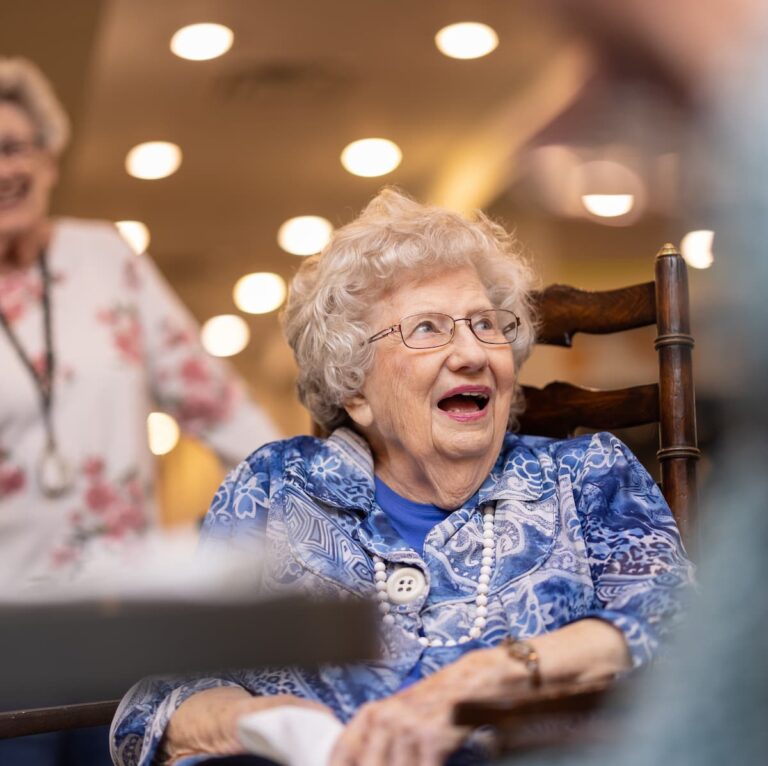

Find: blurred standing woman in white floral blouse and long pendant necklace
0;59;277;586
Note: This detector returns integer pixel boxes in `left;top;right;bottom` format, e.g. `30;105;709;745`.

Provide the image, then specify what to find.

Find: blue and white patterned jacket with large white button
112;428;692;766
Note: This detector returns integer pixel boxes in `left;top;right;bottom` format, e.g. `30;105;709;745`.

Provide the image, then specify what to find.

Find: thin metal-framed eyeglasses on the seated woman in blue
368;309;520;348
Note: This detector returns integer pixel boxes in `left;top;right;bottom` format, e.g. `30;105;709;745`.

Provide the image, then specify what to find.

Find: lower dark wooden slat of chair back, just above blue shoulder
520;381;659;438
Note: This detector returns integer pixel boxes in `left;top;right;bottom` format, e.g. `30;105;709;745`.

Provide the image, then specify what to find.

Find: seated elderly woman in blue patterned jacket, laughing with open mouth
112;190;690;766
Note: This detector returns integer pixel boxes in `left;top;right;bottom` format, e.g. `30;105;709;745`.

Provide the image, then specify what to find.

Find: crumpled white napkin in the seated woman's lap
237;705;344;766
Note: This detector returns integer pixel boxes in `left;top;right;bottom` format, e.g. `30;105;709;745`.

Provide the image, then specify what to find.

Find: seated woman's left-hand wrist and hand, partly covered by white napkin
162;686;335;766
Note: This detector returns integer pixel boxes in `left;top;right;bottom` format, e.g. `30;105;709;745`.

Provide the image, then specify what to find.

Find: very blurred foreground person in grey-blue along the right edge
488;0;768;766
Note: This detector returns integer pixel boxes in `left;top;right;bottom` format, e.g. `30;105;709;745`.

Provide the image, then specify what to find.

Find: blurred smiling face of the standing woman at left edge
0;101;56;236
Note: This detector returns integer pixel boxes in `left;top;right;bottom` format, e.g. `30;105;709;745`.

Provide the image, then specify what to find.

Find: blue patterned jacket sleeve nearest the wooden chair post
574;434;693;667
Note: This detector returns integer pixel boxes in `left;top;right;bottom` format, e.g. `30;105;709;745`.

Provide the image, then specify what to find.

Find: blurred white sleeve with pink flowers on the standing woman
125;249;279;467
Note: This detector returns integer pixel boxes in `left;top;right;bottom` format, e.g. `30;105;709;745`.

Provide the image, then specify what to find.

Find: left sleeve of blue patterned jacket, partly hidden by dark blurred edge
110;460;277;766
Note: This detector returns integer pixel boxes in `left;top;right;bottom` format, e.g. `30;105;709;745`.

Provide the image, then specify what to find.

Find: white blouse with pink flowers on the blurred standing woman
0;219;277;586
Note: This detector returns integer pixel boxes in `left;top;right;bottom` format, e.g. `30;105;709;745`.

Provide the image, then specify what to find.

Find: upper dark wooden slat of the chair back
533;282;656;346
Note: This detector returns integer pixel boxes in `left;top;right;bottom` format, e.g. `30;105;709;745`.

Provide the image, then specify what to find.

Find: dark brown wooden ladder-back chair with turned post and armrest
456;245;699;752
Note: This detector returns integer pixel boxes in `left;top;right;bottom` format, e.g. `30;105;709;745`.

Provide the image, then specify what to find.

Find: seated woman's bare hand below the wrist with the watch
330;649;530;766
